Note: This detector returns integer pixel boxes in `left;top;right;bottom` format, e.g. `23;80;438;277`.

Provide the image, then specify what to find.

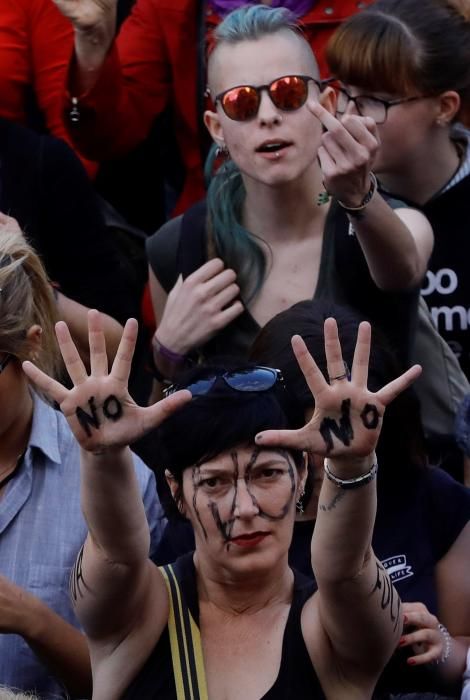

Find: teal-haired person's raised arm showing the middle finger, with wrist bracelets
308;100;434;291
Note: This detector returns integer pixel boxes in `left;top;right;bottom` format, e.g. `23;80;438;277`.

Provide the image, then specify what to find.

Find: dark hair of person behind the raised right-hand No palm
250;301;427;492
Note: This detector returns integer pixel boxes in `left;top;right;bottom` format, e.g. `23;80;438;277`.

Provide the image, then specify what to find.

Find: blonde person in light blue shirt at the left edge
0;227;164;700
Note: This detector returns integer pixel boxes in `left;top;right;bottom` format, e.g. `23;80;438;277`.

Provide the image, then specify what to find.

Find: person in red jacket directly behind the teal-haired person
54;0;371;211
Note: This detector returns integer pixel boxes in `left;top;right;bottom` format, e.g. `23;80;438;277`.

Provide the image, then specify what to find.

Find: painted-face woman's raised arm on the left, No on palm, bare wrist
24;311;190;693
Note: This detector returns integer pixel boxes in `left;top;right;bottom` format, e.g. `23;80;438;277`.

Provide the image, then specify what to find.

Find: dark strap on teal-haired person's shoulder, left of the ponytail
175;200;207;279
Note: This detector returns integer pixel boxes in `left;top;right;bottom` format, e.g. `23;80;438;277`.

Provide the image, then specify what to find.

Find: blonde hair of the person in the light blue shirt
0;227;62;376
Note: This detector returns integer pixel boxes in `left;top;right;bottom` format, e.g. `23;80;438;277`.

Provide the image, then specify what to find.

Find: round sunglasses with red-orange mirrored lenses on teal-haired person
214;75;321;122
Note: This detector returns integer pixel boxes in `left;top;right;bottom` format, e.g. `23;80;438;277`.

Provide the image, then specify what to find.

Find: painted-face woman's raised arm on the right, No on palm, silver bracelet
255;319;420;698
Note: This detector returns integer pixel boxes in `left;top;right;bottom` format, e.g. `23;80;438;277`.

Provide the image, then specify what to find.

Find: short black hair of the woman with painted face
155;362;303;517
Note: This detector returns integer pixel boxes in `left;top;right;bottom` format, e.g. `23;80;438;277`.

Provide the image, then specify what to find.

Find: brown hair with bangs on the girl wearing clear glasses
326;0;470;124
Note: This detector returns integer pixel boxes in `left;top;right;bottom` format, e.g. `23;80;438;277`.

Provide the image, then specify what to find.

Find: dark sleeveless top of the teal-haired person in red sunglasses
147;200;419;363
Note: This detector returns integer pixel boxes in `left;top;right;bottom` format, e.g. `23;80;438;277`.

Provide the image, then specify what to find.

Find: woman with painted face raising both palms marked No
24;312;420;700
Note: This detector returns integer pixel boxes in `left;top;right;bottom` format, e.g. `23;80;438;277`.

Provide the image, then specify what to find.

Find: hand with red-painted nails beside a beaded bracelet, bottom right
398;603;450;666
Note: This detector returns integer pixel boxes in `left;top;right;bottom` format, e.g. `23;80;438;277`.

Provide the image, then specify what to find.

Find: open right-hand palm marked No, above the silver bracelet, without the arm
256;318;421;470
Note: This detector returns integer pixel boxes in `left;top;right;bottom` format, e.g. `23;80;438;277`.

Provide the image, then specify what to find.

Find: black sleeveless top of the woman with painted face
122;552;326;700
